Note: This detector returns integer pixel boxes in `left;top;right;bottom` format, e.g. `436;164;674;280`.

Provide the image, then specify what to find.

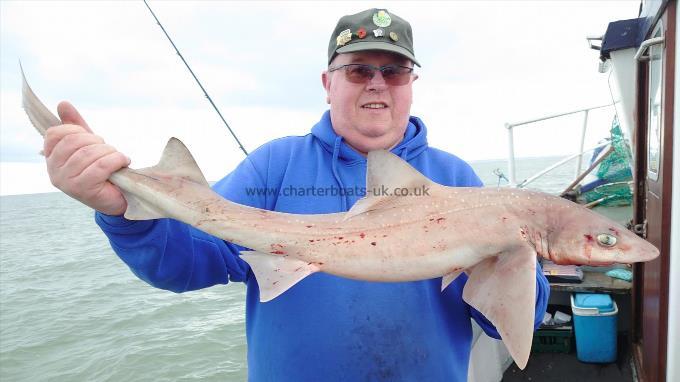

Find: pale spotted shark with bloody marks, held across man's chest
22;70;659;369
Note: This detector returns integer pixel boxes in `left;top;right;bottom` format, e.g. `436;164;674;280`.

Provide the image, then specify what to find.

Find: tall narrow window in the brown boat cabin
647;22;664;181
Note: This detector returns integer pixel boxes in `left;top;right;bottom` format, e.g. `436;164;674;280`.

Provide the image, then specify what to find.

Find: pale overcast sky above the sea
0;0;639;195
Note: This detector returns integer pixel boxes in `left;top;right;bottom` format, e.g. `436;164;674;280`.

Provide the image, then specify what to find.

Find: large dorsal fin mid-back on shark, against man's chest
345;150;438;220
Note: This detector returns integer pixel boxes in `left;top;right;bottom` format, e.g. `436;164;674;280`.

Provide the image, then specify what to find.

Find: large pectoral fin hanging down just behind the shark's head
463;248;536;369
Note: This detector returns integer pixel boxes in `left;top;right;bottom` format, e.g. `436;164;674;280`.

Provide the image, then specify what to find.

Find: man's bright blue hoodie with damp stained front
96;112;549;381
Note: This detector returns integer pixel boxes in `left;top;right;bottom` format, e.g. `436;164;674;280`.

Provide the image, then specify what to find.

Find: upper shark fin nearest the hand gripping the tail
137;137;210;187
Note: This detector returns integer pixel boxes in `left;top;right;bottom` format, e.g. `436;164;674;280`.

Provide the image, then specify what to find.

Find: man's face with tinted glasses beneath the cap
321;51;417;153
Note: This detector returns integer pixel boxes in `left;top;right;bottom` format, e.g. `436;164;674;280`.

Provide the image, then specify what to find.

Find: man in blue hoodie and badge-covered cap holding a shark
45;9;549;381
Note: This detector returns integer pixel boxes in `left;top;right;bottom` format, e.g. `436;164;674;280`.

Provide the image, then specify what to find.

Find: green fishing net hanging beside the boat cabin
581;117;633;206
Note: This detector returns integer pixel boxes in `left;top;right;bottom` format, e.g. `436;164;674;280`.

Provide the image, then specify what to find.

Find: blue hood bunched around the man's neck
312;110;427;164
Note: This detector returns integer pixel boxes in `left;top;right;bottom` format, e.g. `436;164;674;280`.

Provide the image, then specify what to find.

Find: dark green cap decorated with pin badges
328;8;420;66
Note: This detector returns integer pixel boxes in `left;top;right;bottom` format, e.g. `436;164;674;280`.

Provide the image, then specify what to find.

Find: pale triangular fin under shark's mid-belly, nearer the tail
241;251;319;302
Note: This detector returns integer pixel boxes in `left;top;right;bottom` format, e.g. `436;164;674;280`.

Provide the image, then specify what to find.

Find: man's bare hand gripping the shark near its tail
43;102;130;215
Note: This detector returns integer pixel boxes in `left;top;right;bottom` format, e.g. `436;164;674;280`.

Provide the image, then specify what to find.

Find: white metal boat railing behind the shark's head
505;104;614;188
